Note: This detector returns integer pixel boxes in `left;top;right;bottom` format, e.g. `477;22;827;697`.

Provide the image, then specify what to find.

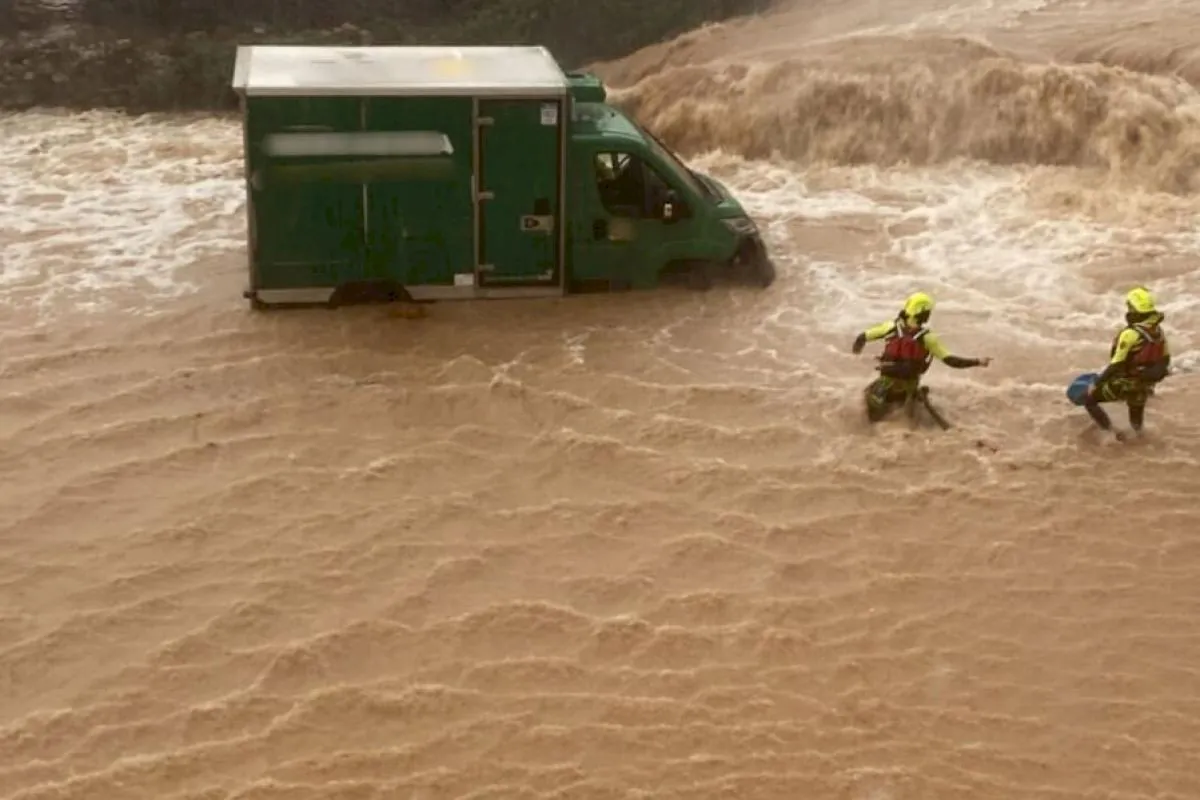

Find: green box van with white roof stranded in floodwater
233;46;775;308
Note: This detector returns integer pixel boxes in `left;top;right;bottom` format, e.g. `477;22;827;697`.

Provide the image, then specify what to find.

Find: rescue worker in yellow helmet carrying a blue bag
1084;287;1171;441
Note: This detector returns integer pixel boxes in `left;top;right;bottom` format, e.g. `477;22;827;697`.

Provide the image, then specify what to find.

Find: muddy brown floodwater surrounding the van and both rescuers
0;0;1200;800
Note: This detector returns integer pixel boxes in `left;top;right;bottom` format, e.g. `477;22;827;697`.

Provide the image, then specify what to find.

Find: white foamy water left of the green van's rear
0;112;245;311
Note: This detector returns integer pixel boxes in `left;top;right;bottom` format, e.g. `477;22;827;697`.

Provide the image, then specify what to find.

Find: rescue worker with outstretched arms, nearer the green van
852;291;991;422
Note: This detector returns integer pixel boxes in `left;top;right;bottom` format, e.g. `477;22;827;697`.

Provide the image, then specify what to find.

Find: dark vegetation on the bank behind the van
0;0;768;112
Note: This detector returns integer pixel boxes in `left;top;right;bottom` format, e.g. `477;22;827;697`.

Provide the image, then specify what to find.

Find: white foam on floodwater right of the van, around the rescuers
698;151;1200;407
